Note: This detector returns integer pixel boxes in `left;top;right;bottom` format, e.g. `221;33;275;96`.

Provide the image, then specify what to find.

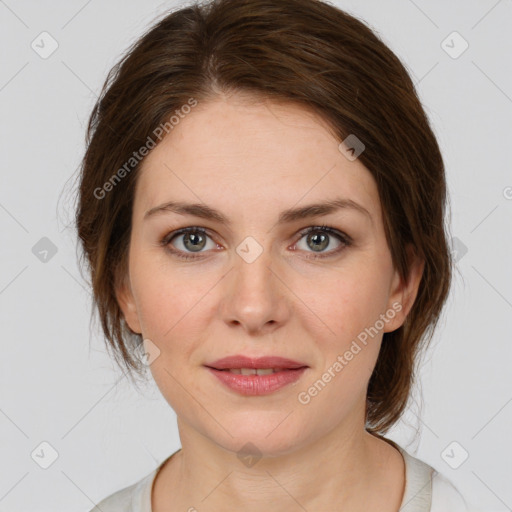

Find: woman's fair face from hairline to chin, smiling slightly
118;92;420;455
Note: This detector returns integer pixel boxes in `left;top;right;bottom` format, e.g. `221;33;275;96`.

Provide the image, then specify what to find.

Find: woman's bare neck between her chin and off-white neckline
154;422;404;512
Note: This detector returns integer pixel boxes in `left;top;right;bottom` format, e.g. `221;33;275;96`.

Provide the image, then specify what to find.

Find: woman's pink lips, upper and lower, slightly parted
205;355;309;396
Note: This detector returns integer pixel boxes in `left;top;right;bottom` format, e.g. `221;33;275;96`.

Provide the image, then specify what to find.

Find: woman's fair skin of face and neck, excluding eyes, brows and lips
117;93;423;512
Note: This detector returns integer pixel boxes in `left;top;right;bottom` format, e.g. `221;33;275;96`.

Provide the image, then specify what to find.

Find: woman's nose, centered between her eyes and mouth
222;240;291;335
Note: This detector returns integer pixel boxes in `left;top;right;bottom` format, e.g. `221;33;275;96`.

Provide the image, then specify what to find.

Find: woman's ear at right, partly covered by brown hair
383;244;425;332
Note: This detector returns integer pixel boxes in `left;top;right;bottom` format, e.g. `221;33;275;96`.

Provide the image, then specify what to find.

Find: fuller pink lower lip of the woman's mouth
208;367;307;396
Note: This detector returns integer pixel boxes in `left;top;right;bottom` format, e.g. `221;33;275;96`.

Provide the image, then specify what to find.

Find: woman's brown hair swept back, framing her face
76;0;452;434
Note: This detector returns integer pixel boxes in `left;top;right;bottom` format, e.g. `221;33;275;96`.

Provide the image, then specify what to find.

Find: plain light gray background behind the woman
0;0;512;512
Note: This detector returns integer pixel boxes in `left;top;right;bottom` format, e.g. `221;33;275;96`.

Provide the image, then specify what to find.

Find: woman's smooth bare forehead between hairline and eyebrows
135;96;379;218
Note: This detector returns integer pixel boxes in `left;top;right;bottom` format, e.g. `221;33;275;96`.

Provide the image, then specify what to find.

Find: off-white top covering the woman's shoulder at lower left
90;469;157;512
